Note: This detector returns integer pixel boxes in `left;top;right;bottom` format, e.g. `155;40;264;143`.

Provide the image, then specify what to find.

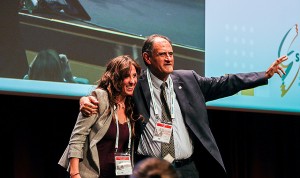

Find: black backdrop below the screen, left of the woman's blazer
0;95;79;178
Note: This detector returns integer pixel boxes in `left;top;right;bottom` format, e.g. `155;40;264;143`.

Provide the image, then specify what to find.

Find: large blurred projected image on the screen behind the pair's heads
0;0;205;97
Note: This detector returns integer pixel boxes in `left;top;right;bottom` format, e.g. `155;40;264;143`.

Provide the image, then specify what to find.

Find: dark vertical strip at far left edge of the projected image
0;0;28;78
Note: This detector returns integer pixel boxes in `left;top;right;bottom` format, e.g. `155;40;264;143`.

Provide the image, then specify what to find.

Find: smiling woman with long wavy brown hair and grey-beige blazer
59;55;141;178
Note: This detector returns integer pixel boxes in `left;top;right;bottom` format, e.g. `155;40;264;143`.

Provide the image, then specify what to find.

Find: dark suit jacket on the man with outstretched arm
134;70;268;177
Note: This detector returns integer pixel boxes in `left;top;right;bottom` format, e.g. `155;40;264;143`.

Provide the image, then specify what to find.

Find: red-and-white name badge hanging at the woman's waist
115;153;132;176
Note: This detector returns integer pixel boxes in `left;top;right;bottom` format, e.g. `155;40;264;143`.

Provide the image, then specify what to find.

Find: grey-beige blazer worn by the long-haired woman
58;89;114;178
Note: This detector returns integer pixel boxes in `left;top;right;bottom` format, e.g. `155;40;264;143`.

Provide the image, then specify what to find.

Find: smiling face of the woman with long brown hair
122;65;137;96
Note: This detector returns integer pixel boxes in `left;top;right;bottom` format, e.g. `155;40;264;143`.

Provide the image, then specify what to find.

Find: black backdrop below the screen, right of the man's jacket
209;110;300;178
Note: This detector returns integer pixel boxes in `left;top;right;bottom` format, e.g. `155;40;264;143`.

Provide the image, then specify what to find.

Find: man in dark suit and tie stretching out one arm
80;34;287;178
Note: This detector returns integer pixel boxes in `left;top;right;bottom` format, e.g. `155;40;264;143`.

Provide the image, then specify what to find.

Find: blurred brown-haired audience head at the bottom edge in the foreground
130;157;179;178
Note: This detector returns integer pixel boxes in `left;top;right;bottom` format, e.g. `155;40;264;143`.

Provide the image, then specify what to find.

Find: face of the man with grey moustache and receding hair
147;37;174;81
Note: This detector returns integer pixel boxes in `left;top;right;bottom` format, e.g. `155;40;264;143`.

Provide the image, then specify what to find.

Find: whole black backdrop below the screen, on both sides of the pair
0;95;300;178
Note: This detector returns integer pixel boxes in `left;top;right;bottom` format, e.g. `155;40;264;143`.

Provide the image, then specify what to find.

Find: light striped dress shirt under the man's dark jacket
138;72;194;160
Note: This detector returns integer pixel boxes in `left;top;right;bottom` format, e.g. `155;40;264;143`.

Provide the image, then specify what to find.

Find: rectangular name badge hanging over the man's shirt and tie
153;122;173;143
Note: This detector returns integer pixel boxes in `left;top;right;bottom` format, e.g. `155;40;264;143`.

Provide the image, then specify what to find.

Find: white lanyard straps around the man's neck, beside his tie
147;68;175;119
